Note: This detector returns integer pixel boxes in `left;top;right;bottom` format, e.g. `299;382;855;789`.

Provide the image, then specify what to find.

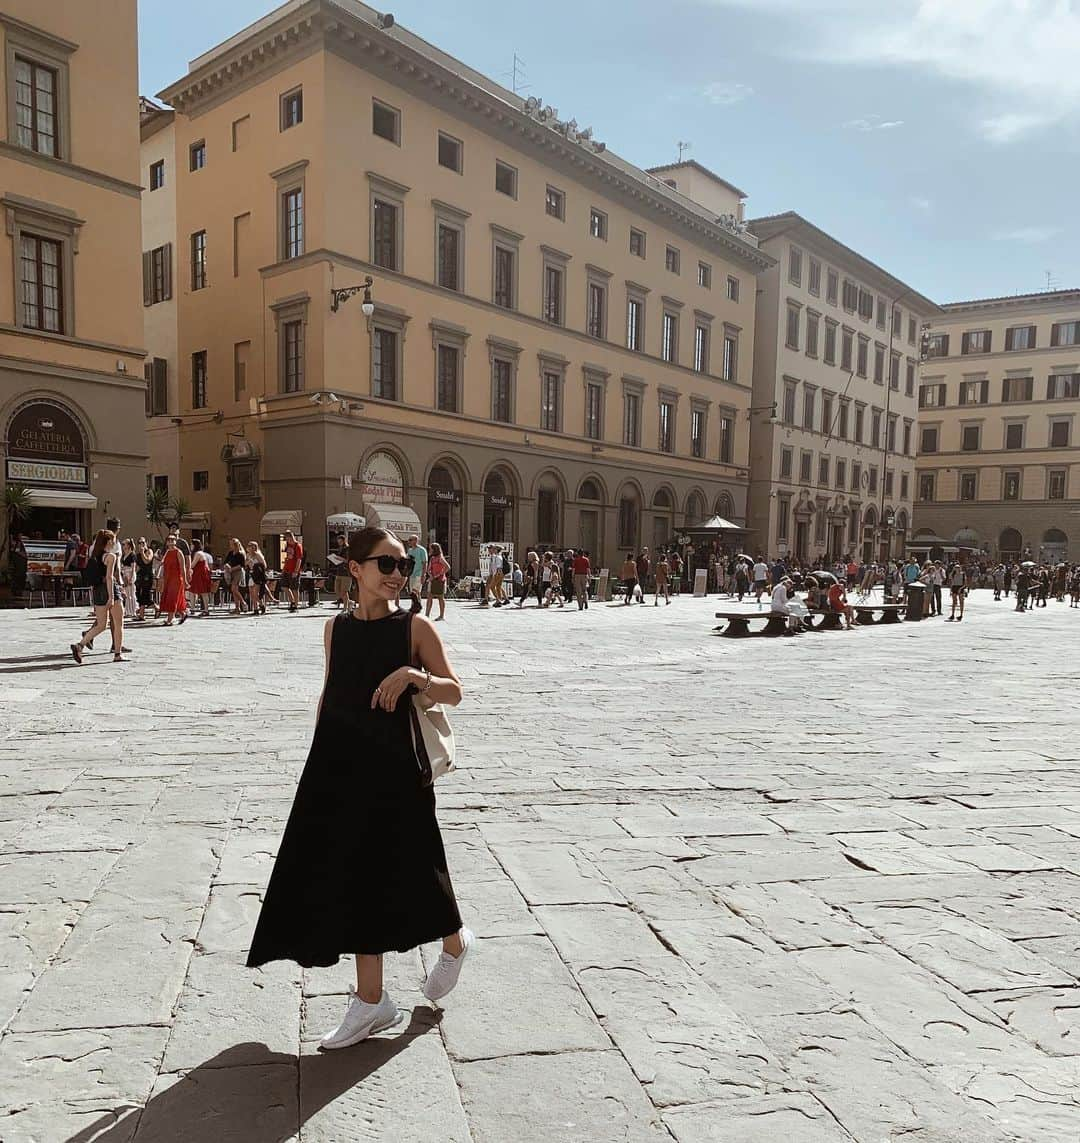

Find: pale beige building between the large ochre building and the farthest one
749;213;937;561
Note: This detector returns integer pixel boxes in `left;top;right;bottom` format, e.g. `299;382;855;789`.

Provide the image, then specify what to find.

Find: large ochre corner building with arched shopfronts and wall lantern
150;0;771;573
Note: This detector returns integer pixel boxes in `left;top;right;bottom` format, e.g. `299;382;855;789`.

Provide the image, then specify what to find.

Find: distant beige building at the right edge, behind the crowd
915;290;1080;561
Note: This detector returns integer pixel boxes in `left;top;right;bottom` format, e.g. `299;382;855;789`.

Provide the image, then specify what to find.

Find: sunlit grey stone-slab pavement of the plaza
0;592;1080;1143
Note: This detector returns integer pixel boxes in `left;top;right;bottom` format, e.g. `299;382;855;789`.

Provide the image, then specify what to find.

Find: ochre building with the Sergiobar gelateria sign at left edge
0;0;146;541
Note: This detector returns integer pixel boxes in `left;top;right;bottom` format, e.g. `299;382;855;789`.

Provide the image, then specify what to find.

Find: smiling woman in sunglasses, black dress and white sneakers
248;528;474;1048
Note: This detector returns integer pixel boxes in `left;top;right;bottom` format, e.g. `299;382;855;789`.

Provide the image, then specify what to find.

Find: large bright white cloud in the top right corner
701;0;1080;144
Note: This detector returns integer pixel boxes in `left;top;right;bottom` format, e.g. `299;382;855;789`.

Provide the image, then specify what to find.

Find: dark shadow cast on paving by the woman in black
66;1008;442;1143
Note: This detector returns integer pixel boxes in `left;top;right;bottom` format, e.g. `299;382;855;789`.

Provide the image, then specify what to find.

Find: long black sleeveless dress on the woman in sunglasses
248;610;462;968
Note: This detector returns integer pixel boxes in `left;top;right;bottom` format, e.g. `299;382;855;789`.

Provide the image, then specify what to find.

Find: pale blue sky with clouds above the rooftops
139;0;1080;302
